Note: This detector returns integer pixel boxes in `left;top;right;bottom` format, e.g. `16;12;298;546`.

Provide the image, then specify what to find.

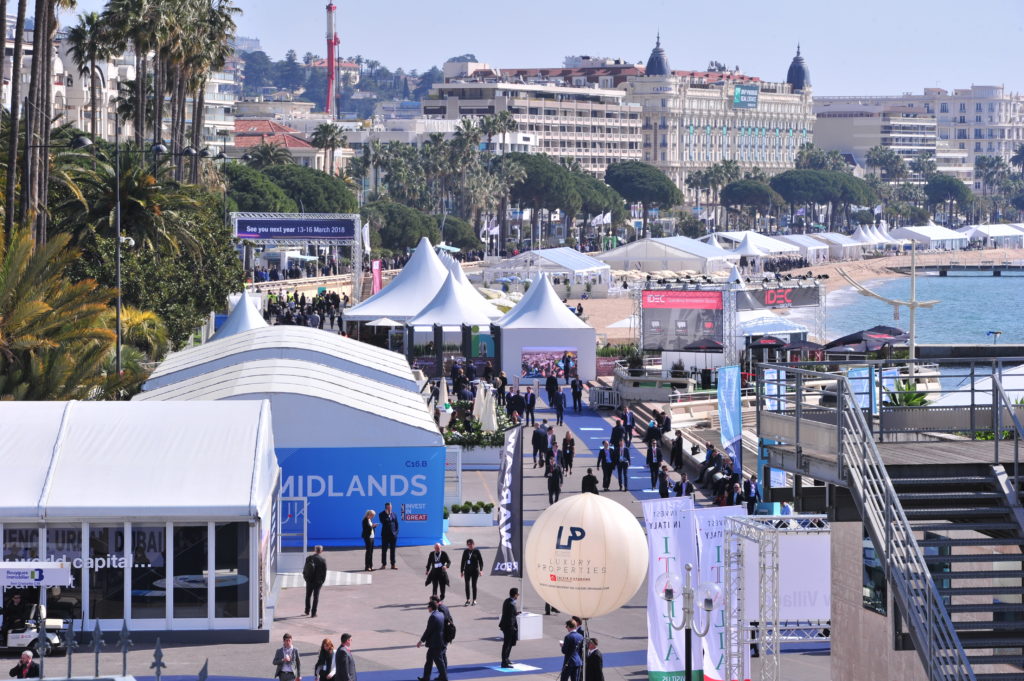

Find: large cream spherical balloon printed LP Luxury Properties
525;494;647;619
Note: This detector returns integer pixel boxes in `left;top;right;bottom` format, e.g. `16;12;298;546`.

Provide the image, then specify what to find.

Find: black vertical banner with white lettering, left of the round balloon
490;428;522;577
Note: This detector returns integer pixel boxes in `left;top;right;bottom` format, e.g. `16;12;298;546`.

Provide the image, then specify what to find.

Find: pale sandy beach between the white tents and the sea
569;249;1024;343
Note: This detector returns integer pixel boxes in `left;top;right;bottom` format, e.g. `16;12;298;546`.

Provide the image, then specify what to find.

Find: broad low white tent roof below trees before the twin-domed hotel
597;237;739;274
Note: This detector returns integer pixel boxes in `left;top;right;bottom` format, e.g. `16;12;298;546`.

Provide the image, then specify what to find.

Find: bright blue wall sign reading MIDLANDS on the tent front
278;446;444;546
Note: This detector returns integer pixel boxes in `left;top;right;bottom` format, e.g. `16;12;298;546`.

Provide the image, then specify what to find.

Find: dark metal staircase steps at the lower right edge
888;464;1024;681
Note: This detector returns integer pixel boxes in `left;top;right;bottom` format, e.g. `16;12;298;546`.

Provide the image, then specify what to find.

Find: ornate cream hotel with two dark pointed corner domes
625;39;814;195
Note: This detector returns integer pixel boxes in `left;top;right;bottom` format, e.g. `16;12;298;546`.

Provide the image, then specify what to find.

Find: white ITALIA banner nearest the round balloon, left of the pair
643;497;700;681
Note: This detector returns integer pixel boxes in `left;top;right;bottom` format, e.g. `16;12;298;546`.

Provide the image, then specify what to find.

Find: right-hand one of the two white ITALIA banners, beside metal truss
694;505;751;681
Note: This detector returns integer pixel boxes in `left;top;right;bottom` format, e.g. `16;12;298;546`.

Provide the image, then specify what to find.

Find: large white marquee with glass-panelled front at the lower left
0;401;281;641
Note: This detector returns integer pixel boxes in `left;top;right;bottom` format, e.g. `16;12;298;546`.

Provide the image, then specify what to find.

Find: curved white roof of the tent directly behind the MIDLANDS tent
143;325;417;390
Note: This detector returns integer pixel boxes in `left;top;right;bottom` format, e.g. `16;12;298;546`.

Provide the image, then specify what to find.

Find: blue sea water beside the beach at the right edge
825;274;1024;344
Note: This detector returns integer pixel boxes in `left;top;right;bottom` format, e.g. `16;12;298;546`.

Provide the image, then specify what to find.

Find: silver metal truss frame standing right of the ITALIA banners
724;515;831;681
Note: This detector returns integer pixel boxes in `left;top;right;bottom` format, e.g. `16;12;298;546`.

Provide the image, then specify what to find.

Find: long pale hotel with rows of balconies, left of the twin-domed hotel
423;62;641;177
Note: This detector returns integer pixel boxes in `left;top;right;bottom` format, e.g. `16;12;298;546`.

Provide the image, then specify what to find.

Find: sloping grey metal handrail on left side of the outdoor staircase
759;365;976;681
